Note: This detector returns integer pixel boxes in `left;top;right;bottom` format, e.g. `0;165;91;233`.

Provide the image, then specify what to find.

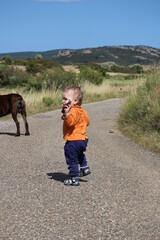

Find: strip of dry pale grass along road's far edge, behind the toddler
0;75;144;119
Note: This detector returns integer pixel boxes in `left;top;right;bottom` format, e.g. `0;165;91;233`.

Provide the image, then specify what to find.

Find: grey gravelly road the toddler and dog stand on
0;99;160;240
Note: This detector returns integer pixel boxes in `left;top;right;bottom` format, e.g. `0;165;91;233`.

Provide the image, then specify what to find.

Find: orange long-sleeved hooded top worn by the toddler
62;105;90;141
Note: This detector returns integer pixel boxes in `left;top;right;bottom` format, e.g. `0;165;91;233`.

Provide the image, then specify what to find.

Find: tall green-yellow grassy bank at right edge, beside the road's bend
118;70;160;153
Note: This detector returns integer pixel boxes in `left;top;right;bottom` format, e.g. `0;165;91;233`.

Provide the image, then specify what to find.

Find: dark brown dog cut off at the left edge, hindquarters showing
0;93;30;136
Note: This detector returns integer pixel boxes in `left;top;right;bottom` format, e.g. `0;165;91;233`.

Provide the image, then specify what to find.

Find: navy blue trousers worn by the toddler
64;139;88;177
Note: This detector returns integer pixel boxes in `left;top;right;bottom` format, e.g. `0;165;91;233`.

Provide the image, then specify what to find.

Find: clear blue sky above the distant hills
0;0;160;53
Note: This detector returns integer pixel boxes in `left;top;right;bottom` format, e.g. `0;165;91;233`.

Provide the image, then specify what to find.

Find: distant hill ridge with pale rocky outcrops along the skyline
0;45;160;66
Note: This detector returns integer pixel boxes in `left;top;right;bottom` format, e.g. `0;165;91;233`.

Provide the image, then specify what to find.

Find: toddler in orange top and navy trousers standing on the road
62;86;91;186
